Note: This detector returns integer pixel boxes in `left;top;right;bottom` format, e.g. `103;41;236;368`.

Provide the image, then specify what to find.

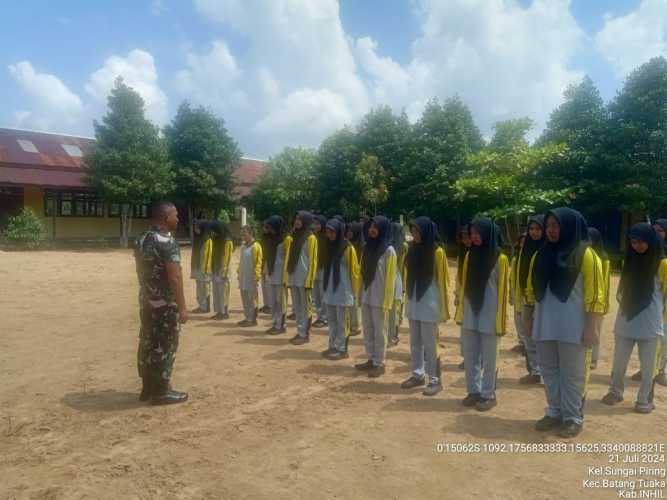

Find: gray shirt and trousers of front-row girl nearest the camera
533;274;587;424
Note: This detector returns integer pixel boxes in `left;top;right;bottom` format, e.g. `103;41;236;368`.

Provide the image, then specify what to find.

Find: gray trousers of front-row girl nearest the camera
536;340;587;424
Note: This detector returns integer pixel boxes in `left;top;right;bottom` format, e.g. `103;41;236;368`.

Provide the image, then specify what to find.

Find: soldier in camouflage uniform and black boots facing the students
134;202;188;405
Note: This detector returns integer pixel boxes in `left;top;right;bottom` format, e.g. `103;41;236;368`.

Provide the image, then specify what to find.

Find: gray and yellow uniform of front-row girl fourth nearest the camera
361;246;396;366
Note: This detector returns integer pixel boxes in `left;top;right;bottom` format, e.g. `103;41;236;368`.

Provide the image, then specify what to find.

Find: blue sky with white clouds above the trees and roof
0;0;667;158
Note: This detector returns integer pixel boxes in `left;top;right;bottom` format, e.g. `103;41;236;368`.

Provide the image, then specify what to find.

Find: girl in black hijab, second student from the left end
211;221;234;319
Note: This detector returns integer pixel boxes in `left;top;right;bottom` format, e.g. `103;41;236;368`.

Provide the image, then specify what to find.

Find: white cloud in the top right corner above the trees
595;0;667;76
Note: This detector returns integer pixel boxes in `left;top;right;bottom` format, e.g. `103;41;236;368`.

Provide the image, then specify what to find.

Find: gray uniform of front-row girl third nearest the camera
407;282;440;384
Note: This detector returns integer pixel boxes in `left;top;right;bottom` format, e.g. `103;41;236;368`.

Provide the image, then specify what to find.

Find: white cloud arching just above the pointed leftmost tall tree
85;49;168;125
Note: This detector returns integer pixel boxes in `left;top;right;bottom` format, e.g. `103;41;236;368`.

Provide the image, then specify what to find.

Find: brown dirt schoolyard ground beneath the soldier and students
0;249;667;499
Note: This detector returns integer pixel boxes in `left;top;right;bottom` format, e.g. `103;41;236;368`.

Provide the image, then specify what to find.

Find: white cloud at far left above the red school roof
8;61;84;130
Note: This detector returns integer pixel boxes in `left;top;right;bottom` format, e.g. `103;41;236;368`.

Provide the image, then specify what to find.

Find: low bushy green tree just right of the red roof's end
248;148;317;220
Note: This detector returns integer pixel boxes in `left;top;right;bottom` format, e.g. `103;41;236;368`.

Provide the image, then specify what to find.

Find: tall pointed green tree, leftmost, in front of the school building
84;78;174;247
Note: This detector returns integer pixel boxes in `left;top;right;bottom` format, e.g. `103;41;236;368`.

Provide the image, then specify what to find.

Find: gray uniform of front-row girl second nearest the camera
463;263;499;399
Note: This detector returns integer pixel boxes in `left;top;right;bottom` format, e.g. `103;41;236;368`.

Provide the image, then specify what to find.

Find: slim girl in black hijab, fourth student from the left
264;215;292;335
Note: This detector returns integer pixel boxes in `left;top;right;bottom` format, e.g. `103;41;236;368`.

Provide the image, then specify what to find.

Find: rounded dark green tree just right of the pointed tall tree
164;101;241;241
